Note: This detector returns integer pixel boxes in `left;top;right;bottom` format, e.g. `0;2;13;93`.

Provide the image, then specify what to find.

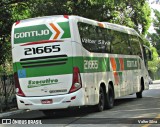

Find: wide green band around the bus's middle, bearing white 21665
14;56;140;77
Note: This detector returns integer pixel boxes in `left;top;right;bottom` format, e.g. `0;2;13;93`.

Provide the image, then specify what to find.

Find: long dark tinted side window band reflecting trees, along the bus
78;22;141;55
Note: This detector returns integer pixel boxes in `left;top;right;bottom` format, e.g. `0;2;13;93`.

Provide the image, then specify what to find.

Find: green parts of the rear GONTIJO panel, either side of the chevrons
13;22;71;44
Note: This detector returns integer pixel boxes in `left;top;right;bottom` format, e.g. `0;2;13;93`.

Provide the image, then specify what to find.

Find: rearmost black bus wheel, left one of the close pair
96;87;105;112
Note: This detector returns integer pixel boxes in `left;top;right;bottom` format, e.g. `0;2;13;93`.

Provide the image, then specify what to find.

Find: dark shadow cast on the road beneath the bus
7;97;141;120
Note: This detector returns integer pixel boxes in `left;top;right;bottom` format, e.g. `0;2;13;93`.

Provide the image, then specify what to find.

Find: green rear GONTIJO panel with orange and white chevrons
14;22;71;44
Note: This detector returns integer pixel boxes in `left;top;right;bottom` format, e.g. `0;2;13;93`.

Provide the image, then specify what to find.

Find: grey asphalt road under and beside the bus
0;81;160;127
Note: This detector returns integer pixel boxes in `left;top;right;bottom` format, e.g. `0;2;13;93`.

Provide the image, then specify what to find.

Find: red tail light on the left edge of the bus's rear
14;73;25;97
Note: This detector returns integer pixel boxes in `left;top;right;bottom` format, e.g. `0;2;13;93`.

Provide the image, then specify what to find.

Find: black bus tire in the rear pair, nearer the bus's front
106;84;114;109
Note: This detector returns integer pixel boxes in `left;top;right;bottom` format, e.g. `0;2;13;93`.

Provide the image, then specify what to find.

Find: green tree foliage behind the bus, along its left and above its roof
0;0;151;73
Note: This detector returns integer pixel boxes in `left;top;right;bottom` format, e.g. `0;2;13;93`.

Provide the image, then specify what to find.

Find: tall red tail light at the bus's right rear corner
69;67;82;93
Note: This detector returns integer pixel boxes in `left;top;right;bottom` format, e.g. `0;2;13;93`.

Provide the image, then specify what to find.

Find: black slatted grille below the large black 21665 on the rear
20;55;68;68
